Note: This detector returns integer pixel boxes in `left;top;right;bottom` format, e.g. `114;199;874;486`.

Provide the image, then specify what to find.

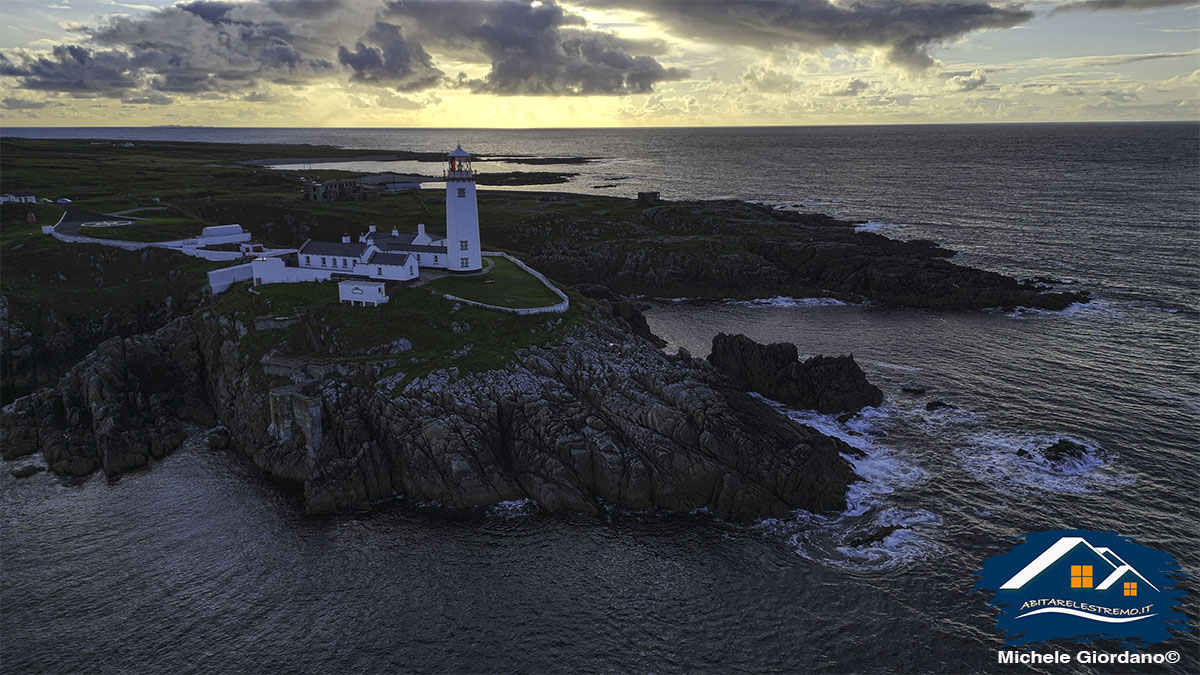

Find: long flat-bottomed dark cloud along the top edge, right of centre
586;0;1033;70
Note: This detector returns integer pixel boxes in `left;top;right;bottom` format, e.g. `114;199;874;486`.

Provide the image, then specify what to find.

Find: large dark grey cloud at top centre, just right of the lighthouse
388;0;686;95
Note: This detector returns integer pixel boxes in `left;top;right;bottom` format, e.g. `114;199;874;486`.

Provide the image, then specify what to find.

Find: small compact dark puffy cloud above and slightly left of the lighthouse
337;22;443;91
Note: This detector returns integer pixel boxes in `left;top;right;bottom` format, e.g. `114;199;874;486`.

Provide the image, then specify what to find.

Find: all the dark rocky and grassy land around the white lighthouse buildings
0;139;1086;519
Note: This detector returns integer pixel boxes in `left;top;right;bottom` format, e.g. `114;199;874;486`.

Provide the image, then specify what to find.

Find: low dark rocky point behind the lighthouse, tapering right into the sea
509;196;1087;310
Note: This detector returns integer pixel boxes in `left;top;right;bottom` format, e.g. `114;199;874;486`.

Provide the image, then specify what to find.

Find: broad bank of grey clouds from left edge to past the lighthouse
0;0;686;103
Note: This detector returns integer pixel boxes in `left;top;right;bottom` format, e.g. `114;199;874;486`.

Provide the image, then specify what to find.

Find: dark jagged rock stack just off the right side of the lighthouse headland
708;333;883;413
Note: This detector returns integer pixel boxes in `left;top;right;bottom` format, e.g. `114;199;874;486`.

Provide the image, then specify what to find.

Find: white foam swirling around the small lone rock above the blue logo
955;431;1135;495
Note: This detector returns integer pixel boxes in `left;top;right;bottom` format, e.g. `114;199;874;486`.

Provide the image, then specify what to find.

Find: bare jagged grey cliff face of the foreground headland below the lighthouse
0;311;854;519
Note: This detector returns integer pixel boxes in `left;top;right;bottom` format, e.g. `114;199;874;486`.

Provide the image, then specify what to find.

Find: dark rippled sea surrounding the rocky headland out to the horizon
0;124;1200;673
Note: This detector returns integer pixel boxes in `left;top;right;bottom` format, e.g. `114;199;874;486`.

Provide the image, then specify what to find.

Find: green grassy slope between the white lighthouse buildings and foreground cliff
216;276;590;382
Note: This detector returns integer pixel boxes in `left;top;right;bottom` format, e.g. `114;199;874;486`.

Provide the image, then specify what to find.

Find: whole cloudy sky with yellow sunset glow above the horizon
0;0;1200;127
